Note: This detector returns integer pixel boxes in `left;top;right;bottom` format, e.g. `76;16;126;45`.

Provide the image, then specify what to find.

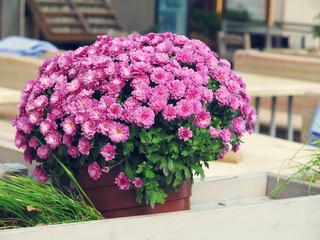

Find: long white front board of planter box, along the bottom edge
0;189;320;240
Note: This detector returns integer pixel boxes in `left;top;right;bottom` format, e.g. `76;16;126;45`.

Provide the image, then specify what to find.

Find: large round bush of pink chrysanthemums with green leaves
13;33;256;206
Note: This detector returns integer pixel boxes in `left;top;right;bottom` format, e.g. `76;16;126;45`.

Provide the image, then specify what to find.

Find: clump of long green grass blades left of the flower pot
0;172;103;229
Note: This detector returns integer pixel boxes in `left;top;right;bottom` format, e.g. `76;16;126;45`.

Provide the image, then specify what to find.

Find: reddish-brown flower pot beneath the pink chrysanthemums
75;168;191;218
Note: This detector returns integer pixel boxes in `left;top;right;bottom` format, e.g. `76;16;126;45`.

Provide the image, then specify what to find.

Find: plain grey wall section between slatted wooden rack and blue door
111;0;156;33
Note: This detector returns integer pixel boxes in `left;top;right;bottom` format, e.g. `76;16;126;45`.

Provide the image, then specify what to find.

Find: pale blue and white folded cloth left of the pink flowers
0;36;58;56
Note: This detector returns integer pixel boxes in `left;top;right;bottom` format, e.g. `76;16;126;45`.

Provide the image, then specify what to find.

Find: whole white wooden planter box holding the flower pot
0;173;320;240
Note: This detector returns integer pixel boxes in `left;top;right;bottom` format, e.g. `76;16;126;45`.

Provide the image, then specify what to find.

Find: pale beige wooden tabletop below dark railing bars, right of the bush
204;133;316;177
